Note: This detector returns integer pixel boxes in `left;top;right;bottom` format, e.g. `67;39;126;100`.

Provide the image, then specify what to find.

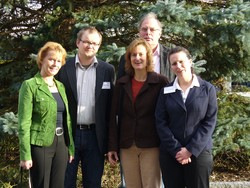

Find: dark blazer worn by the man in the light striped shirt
56;57;115;154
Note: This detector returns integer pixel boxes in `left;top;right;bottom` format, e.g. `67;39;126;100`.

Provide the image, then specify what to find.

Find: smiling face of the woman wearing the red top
130;45;147;71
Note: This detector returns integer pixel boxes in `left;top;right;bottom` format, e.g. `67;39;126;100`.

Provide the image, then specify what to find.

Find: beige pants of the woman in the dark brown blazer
120;145;161;188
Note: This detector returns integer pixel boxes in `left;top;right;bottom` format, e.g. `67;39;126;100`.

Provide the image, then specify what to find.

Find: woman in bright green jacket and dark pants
18;42;74;188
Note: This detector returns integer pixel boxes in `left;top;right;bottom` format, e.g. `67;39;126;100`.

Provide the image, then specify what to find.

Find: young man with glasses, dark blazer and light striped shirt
57;27;115;188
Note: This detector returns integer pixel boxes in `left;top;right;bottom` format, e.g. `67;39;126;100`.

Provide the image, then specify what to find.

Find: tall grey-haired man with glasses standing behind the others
117;12;175;81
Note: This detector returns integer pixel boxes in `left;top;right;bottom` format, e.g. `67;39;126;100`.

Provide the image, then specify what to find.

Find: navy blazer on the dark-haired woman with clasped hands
155;77;218;157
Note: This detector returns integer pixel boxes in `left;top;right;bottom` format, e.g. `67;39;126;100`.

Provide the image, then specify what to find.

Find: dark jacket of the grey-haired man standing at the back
117;44;175;82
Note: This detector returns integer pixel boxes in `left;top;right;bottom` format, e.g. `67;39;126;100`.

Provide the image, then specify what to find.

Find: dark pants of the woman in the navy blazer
160;151;213;188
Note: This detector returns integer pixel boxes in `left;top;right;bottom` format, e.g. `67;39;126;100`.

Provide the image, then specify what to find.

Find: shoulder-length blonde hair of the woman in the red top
125;38;154;76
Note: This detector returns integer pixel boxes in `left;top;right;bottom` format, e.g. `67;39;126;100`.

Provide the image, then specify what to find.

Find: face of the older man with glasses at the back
139;18;161;50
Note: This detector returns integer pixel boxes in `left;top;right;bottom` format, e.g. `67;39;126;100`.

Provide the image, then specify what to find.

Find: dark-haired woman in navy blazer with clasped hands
155;47;218;188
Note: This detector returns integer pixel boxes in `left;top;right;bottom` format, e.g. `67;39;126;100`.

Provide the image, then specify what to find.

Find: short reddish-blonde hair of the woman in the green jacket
36;41;67;69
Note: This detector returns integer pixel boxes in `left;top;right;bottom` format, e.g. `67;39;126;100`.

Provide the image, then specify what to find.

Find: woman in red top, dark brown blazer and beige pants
108;38;168;188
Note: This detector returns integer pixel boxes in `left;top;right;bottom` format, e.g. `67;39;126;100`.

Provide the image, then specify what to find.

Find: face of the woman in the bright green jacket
41;50;62;77
